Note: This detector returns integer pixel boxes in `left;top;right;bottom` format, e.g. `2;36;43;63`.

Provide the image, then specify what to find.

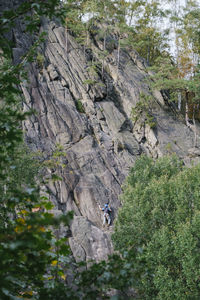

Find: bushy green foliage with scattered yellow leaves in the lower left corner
0;143;72;299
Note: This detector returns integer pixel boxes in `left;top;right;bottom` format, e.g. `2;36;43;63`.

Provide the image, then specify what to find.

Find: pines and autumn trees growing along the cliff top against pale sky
64;0;200;131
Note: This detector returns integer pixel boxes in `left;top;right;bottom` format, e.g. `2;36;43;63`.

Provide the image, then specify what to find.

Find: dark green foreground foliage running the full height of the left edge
0;1;75;299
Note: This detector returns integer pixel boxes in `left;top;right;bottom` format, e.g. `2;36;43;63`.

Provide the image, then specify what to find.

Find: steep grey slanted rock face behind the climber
8;4;200;261
